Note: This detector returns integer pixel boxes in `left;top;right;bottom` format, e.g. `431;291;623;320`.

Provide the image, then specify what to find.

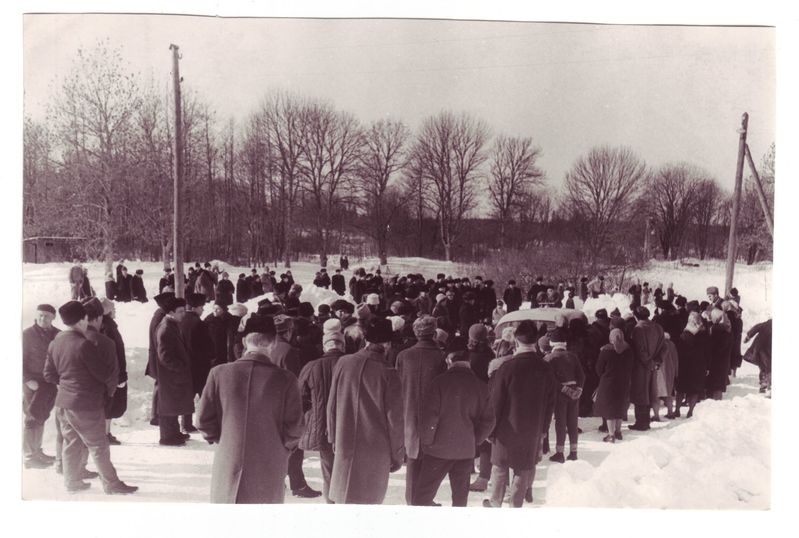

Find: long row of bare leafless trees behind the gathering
24;42;773;267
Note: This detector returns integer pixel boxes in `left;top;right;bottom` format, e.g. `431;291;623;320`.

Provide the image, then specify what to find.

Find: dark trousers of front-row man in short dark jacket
413;454;474;506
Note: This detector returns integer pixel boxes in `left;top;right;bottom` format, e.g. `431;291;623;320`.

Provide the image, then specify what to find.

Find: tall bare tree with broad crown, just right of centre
413;112;489;261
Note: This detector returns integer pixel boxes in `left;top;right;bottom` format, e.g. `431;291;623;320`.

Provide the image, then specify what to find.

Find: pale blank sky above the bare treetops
23;15;776;195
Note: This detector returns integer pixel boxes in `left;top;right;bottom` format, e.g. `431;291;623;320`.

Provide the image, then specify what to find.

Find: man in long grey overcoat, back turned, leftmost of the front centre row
197;333;303;504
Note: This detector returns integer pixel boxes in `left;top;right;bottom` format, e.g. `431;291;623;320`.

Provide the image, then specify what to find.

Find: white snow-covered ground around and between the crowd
22;258;772;509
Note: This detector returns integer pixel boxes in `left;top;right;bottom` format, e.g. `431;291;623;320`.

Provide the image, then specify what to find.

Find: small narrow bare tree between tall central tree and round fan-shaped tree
488;135;544;247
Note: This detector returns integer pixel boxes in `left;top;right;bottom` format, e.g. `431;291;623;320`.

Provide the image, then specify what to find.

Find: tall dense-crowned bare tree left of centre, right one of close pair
299;103;362;267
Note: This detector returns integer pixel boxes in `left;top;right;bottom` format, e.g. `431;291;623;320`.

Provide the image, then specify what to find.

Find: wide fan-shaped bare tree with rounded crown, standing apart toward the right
565;146;647;269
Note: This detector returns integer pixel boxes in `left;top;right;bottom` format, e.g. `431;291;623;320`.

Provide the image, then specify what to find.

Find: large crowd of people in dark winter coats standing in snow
23;260;771;507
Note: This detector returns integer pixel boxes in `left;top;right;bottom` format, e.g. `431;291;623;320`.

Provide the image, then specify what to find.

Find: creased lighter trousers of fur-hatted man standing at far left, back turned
56;408;119;487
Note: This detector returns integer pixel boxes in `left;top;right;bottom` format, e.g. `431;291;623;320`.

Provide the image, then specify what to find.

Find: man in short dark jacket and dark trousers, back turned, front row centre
413;350;495;506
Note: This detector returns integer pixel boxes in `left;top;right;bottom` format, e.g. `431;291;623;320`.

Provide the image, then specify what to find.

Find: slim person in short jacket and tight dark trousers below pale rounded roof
544;329;585;463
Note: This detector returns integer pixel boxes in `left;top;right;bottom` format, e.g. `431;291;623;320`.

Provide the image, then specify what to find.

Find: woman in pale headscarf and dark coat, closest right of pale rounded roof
594;329;633;443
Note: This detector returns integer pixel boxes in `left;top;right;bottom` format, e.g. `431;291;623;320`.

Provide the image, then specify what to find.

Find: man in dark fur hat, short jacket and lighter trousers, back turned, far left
44;301;138;495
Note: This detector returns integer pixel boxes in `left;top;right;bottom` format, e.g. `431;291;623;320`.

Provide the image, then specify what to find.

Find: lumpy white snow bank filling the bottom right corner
546;394;771;510
